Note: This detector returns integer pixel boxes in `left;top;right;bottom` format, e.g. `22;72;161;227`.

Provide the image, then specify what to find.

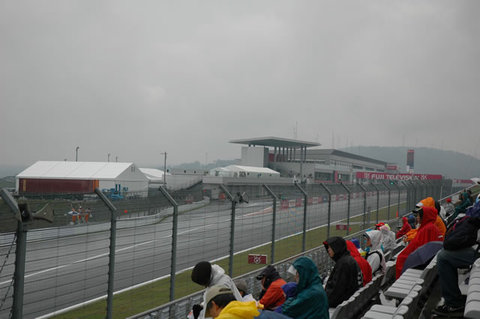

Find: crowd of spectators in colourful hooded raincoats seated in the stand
189;192;480;319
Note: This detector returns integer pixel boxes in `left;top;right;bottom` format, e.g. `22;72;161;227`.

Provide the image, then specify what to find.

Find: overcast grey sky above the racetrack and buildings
0;0;480;171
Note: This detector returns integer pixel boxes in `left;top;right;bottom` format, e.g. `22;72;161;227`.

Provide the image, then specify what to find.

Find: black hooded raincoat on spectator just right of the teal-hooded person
323;237;363;308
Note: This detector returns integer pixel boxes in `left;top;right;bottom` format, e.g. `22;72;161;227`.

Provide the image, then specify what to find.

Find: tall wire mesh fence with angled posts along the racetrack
0;182;468;318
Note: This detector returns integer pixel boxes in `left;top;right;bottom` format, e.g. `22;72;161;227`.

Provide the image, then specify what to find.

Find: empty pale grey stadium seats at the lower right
330;239;480;319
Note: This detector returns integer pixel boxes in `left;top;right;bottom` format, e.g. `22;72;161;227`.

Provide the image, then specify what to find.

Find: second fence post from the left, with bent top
95;188;117;319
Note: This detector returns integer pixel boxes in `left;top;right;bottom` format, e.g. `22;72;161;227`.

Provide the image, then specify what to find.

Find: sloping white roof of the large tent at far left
17;161;133;179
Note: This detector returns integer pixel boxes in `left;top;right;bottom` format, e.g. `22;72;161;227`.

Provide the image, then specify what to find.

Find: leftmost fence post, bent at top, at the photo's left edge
0;188;27;319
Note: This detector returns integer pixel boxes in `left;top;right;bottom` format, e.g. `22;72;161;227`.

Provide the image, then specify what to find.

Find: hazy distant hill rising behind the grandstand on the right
341;146;480;179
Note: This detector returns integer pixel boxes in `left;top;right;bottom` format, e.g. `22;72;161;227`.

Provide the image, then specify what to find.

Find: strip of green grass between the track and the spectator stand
53;203;406;319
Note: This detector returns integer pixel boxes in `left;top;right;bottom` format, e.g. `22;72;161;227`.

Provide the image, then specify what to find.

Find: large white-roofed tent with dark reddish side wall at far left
16;161;148;194
